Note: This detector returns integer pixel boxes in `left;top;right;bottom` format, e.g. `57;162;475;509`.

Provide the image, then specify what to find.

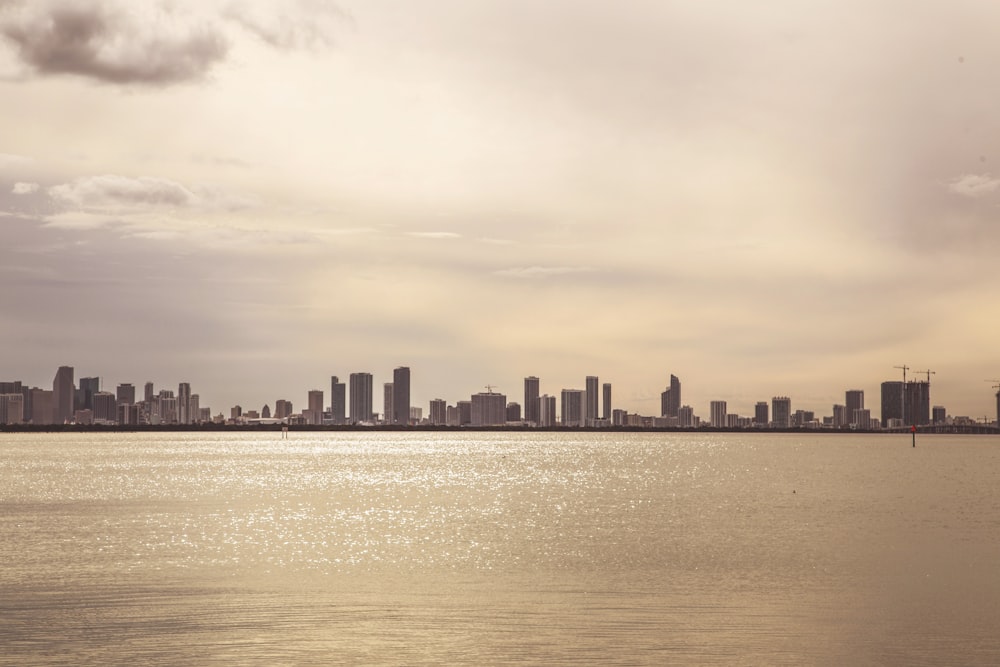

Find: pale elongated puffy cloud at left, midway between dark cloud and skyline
48;174;251;211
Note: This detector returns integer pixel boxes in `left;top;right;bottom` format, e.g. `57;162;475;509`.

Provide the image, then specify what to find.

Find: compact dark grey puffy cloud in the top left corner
0;1;228;86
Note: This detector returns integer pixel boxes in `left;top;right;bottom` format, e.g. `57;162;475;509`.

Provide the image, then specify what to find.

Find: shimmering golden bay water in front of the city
0;433;1000;665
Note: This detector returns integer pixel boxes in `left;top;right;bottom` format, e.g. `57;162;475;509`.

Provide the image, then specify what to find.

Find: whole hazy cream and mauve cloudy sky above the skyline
0;0;1000;418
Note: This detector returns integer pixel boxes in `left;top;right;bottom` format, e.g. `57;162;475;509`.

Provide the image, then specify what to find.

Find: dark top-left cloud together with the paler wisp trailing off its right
0;0;346;86
